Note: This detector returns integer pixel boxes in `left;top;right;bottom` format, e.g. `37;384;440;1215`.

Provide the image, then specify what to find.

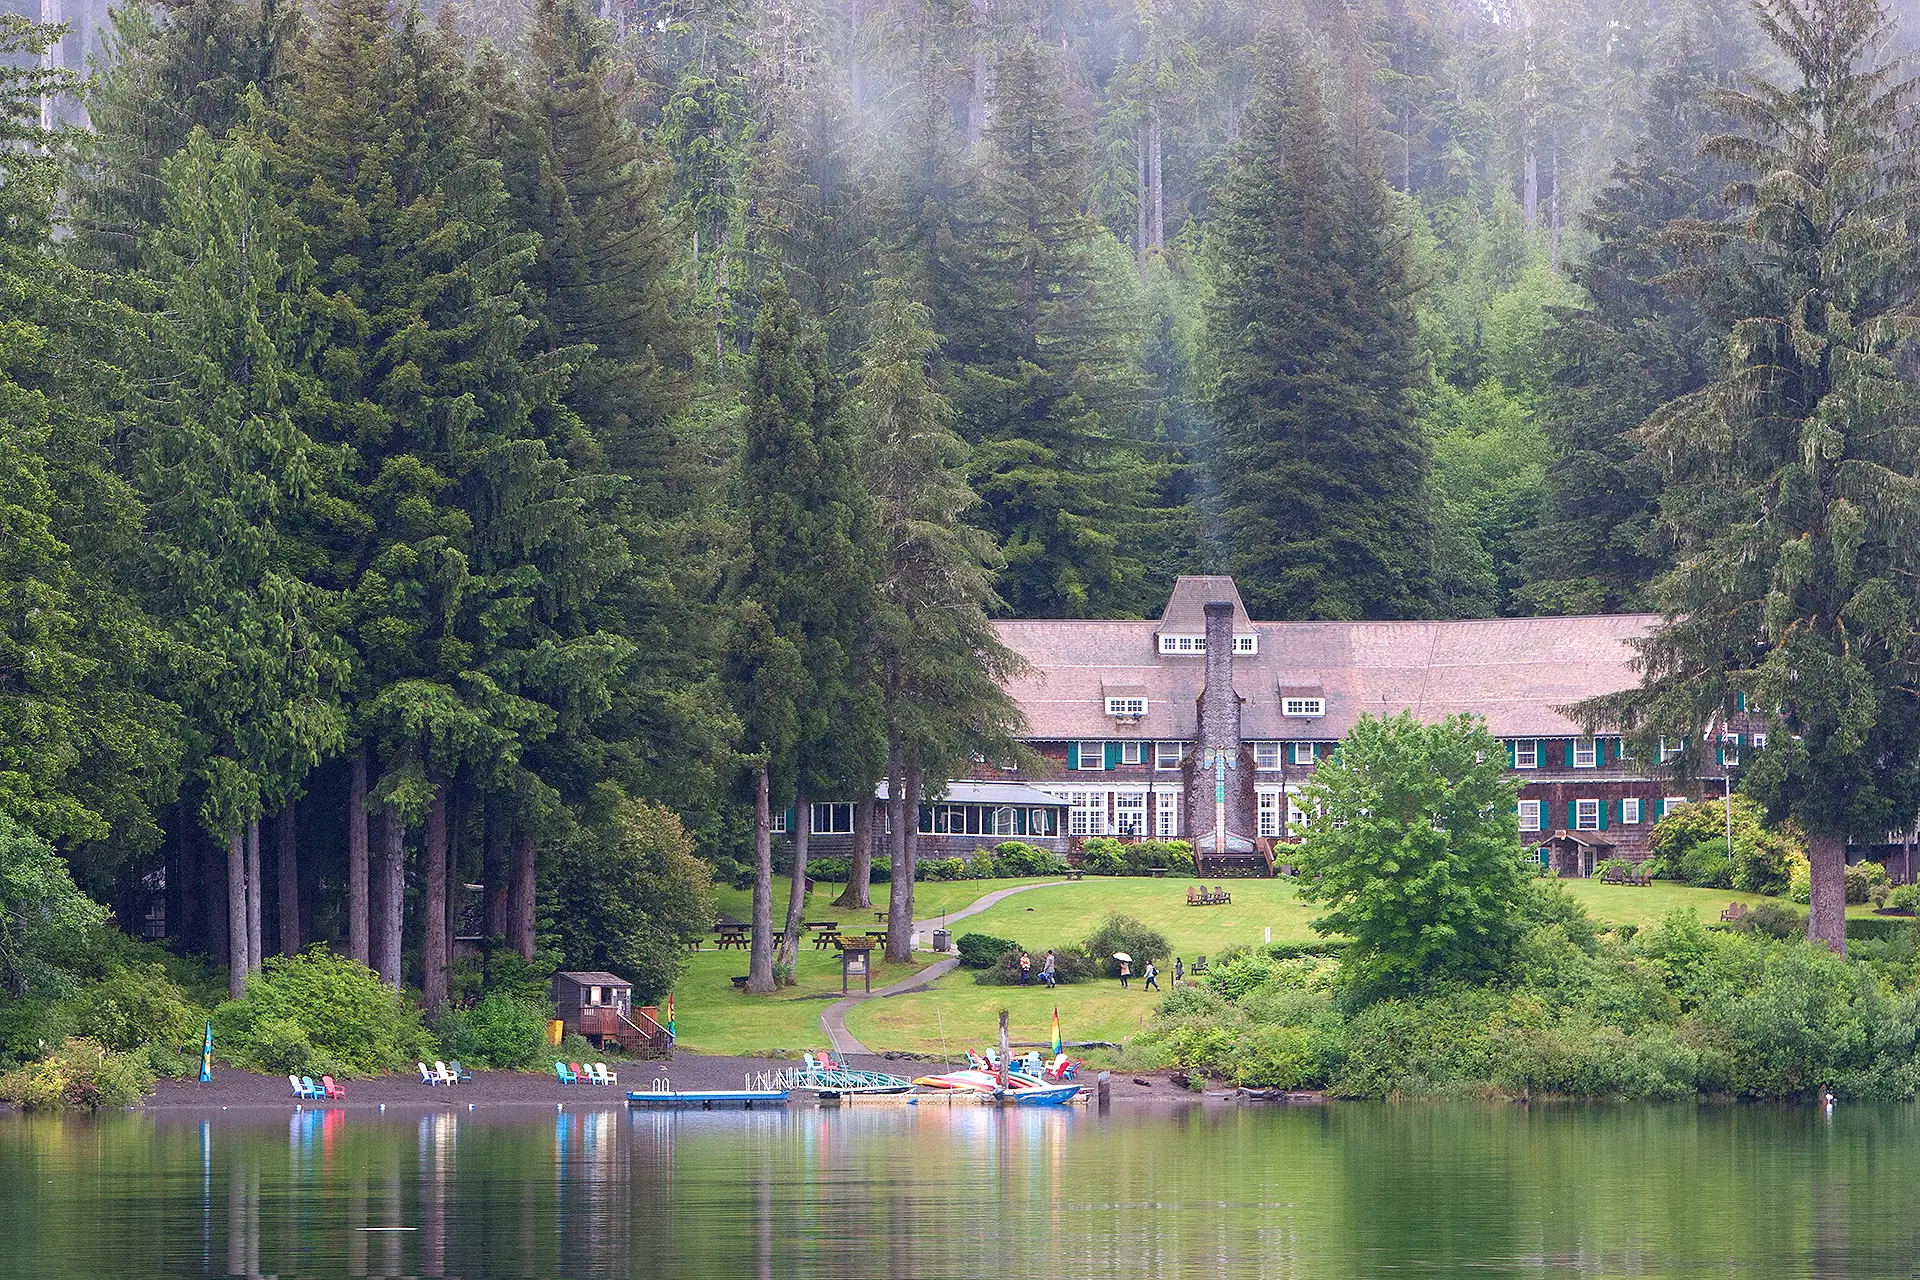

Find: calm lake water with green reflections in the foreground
0;1103;1920;1280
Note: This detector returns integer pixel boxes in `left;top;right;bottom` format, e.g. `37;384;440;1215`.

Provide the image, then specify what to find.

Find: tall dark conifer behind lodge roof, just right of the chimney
1206;29;1430;618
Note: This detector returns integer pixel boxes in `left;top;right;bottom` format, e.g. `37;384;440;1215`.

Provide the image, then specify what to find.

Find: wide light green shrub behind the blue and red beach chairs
213;946;430;1075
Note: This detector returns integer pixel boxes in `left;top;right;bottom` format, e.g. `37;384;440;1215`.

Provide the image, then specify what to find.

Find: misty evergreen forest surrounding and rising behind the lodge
0;0;1920;1028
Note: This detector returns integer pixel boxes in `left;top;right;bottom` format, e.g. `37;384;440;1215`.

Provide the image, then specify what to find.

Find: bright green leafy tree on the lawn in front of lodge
1294;714;1528;992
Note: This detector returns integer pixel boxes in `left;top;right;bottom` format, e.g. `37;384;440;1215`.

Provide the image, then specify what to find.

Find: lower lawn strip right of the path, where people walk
847;971;1159;1061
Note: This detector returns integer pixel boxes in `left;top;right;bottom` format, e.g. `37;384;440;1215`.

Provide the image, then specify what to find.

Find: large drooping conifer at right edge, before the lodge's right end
1584;0;1920;950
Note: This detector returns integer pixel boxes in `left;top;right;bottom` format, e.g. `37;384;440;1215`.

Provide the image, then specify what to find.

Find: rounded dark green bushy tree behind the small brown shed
553;789;714;1004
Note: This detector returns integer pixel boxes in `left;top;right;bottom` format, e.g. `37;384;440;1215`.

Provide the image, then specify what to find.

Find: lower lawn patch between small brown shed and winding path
674;942;933;1057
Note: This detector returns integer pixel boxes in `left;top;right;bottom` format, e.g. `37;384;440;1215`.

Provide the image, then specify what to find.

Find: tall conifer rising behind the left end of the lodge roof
941;36;1154;616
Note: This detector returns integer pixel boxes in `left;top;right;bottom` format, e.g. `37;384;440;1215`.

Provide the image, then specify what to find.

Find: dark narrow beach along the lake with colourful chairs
132;1054;1235;1111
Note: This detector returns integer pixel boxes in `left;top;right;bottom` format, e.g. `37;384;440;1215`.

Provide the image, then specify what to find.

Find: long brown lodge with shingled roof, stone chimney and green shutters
812;576;1764;875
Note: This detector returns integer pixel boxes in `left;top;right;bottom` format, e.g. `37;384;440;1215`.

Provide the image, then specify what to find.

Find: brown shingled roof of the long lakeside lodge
996;578;1657;741
